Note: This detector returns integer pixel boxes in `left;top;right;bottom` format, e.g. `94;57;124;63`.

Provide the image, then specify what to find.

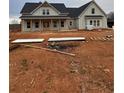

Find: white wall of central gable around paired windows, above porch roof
33;7;59;16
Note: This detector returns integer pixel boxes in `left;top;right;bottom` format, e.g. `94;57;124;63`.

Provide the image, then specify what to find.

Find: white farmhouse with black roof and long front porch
20;0;107;31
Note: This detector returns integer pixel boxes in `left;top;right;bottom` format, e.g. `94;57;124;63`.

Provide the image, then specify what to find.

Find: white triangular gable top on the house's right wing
79;2;106;17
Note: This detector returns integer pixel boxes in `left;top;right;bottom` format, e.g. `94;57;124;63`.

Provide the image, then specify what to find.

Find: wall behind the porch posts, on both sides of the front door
21;19;69;32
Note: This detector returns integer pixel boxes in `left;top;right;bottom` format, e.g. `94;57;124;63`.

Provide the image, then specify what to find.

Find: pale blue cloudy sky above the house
9;0;114;23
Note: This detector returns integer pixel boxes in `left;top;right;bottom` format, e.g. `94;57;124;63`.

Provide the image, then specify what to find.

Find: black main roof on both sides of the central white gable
20;1;92;18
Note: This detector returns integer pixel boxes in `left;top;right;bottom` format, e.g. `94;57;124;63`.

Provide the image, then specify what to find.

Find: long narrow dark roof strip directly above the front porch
20;16;70;19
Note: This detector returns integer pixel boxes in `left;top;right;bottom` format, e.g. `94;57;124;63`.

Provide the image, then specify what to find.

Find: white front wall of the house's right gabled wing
79;3;107;29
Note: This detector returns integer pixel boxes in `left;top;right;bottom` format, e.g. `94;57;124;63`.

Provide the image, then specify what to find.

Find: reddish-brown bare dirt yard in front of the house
9;29;114;93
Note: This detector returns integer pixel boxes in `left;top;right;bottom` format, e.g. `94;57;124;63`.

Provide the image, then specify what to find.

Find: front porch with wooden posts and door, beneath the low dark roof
21;19;68;31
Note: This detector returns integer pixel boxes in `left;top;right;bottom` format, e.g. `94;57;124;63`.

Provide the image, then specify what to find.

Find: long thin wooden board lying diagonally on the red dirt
21;44;75;56
